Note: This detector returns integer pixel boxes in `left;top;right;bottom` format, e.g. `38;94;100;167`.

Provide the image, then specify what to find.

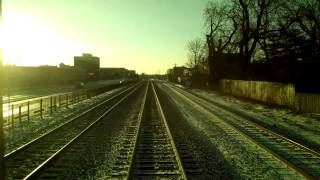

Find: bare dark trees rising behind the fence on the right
186;0;320;90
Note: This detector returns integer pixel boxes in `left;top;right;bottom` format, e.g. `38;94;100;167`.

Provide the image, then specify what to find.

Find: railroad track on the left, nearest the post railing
5;83;142;179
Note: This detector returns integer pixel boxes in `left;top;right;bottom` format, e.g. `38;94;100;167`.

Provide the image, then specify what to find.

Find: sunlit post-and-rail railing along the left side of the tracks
3;81;131;128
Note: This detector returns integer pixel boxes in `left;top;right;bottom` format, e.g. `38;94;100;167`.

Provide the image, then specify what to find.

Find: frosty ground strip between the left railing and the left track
4;86;128;153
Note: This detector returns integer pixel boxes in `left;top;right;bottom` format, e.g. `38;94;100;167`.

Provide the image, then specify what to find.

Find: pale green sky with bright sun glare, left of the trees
0;0;208;74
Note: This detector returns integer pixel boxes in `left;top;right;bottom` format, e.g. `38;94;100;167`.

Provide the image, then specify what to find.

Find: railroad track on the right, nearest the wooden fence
164;84;320;179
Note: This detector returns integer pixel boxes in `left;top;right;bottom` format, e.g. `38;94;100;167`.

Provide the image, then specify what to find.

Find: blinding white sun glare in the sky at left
0;11;85;66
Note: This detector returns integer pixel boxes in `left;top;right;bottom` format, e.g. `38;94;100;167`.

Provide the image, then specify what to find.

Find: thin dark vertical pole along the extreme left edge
0;0;5;180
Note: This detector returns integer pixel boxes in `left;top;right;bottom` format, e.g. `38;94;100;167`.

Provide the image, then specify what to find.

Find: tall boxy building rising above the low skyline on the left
74;53;100;80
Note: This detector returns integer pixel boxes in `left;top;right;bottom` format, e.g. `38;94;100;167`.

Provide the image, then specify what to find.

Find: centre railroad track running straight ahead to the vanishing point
110;82;186;179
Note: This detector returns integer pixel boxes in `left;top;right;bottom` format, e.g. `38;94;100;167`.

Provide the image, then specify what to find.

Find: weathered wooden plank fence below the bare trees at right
220;79;320;112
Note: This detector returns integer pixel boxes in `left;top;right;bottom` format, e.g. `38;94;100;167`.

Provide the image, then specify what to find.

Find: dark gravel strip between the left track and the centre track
42;85;142;179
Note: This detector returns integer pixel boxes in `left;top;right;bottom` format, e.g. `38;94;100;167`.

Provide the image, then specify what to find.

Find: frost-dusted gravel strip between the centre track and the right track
162;82;302;179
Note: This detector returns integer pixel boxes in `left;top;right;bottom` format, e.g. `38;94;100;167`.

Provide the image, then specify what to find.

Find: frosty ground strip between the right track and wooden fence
185;86;320;151
